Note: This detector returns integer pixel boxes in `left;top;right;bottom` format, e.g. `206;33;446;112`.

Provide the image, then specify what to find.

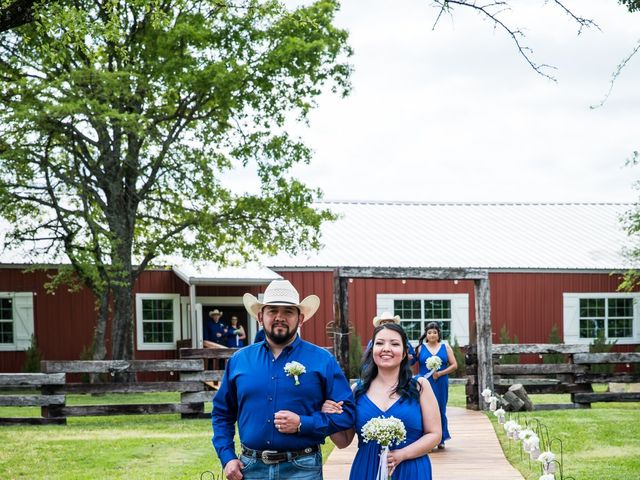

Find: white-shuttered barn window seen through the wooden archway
376;294;469;345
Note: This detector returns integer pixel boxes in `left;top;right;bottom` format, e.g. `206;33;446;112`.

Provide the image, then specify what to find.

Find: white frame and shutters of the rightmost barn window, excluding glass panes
562;292;640;345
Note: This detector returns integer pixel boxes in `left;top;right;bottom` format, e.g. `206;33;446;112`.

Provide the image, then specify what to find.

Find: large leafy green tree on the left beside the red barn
0;0;350;359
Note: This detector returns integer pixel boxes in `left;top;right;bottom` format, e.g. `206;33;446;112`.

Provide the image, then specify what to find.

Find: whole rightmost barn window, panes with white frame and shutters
563;292;640;345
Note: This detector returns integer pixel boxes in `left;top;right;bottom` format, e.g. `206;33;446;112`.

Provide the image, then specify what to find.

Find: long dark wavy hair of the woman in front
354;323;422;399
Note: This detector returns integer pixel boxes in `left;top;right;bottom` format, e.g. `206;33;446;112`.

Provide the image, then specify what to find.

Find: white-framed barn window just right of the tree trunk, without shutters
136;294;180;350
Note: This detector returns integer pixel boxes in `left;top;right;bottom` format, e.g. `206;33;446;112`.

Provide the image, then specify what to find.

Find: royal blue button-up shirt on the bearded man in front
211;337;355;466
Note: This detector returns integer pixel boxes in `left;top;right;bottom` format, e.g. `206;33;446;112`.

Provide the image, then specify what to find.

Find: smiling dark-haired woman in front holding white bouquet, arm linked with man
322;323;441;480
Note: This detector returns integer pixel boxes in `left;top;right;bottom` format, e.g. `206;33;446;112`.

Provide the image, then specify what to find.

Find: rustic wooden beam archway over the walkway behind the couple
333;267;493;408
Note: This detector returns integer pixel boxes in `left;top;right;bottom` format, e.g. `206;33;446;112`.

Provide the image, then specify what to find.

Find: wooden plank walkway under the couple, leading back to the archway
324;407;523;480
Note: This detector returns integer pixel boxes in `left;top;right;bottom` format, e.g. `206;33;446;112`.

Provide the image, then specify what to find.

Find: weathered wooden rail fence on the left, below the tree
0;356;221;425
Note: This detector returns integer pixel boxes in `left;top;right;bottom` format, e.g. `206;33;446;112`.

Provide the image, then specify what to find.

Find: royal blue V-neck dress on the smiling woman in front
349;388;431;480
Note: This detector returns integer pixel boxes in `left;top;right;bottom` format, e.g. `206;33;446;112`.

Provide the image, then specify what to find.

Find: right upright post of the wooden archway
474;273;493;410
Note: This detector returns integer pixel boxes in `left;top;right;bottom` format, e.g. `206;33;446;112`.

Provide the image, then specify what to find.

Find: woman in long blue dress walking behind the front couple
416;322;458;449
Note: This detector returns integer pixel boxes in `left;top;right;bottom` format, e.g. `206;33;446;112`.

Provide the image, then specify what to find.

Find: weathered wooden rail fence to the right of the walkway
465;344;640;410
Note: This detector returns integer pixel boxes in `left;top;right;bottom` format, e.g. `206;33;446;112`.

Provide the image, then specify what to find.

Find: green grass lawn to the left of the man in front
0;393;333;480
